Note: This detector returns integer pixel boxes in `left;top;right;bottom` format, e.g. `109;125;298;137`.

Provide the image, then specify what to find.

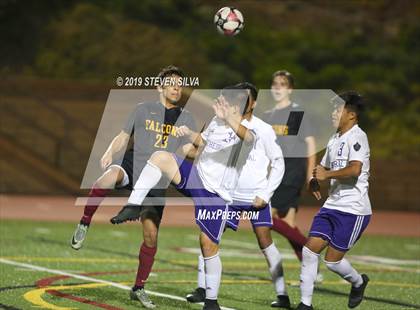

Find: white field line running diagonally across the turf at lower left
0;258;235;310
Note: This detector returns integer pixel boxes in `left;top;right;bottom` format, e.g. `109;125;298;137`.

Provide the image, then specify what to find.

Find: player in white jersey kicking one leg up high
113;83;266;310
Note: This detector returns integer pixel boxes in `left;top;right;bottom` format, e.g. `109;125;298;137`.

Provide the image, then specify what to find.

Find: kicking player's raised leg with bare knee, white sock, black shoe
111;151;181;224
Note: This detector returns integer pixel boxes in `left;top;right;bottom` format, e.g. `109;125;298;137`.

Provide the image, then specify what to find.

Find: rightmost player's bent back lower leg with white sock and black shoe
325;246;369;308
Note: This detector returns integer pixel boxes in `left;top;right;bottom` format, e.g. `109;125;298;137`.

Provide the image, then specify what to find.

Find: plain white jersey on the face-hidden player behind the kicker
232;116;284;203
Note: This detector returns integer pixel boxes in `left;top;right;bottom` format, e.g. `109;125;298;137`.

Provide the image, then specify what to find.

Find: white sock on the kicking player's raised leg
128;161;162;205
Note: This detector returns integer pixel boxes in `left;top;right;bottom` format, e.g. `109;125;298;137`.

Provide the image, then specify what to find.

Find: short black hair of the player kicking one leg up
222;82;258;111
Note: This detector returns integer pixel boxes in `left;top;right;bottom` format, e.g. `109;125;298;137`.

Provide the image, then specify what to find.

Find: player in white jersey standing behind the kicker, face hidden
186;86;290;309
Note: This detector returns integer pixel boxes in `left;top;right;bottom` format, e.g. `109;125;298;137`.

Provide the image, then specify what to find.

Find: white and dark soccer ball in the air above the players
214;6;244;36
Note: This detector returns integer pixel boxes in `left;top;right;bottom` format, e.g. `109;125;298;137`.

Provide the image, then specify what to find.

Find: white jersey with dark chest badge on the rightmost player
321;125;372;215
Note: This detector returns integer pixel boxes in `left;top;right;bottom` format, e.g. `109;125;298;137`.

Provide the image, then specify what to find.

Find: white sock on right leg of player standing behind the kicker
261;243;287;296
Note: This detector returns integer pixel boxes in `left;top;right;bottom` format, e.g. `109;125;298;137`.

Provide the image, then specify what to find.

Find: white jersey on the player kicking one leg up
197;117;241;202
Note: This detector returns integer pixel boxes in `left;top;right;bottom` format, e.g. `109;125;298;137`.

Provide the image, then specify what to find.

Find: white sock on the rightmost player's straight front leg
300;246;319;306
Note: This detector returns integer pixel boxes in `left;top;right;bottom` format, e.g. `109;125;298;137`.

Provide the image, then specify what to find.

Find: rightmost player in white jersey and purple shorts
297;92;372;310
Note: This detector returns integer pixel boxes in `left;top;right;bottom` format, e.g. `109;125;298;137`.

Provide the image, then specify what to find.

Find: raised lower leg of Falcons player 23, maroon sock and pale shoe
70;166;124;250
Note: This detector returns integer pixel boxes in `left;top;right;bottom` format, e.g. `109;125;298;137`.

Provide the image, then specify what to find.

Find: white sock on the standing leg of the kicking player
204;253;222;300
